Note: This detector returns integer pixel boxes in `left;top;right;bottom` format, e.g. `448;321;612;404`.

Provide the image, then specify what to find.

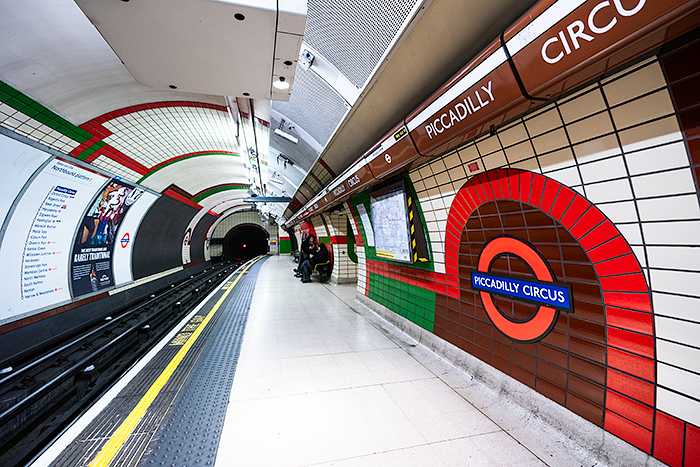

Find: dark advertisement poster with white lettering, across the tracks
70;180;144;298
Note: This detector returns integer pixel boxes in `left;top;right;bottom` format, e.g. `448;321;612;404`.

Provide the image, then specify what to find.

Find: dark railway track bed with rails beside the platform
0;263;240;467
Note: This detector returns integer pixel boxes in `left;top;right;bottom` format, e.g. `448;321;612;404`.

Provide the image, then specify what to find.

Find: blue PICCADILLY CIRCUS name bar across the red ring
472;271;571;311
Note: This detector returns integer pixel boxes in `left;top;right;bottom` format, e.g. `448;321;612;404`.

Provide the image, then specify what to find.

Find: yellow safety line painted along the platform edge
90;256;264;467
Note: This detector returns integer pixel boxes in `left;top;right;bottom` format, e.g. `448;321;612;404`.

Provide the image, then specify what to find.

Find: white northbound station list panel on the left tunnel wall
0;158;108;323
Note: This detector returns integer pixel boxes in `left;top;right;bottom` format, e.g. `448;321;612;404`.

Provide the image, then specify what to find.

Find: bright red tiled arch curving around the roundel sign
445;169;690;457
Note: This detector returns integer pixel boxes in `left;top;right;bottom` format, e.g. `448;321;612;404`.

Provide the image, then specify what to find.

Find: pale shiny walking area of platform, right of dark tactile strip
216;256;600;467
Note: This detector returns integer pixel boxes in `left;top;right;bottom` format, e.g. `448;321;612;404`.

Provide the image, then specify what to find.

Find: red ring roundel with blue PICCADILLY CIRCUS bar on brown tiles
471;235;573;342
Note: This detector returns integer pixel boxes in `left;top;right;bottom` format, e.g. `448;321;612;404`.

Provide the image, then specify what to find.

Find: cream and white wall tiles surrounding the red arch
408;58;700;424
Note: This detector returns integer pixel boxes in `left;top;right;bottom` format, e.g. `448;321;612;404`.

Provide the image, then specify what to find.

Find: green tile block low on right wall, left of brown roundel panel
369;273;435;332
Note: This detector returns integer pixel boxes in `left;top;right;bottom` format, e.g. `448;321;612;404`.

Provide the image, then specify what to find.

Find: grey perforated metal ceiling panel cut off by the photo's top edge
304;0;417;91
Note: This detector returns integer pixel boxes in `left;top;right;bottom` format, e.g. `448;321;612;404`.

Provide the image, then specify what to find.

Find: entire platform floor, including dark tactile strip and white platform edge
34;256;608;467
